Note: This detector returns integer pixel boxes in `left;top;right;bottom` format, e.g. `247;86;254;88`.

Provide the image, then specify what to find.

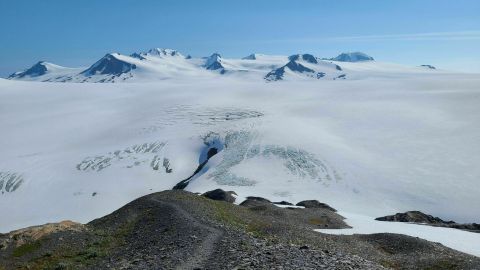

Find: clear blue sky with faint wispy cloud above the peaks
0;0;480;76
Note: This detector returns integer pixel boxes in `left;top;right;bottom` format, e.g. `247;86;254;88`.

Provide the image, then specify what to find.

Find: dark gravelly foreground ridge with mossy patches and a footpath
0;190;480;269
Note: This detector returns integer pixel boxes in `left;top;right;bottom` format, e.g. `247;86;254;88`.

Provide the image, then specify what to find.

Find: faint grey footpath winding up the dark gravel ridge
151;198;224;269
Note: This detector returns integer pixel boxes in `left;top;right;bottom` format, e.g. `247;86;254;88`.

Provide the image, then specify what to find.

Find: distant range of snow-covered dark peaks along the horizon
4;48;446;83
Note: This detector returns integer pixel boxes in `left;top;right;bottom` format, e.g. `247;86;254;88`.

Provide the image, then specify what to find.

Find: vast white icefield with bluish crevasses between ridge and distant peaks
0;65;480;254
